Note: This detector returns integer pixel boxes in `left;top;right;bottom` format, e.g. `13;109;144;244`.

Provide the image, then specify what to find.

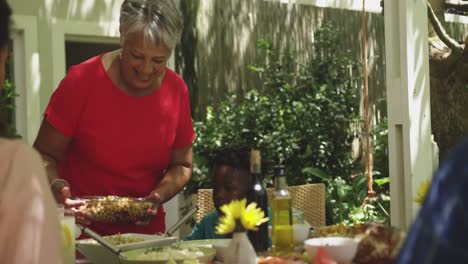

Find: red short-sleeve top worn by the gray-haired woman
44;55;195;234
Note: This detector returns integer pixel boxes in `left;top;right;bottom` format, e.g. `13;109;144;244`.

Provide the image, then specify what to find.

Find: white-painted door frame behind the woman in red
8;0;122;144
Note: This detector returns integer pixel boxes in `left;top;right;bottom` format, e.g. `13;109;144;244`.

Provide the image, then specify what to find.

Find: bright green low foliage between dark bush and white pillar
302;116;390;224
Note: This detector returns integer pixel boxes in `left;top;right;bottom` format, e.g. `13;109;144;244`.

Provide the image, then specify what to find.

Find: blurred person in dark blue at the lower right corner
395;140;468;264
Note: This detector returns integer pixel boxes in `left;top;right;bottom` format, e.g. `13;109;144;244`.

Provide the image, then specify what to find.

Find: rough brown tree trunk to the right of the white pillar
429;0;468;160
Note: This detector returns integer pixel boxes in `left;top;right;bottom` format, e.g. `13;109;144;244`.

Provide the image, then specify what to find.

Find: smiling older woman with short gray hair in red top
34;0;195;235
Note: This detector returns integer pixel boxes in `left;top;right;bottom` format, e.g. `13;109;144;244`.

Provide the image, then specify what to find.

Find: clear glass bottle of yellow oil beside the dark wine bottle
271;165;294;252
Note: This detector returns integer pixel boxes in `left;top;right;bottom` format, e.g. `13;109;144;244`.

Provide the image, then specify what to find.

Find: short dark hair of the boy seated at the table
212;146;250;171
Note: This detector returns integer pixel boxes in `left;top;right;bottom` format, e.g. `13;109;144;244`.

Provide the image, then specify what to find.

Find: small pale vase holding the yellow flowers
224;232;257;264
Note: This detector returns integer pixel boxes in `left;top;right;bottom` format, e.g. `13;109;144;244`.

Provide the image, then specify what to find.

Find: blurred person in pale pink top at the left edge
0;0;61;264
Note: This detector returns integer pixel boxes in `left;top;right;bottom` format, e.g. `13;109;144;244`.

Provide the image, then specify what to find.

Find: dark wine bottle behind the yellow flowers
247;150;269;252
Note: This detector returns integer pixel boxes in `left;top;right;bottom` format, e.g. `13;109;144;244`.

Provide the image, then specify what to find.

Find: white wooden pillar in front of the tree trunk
384;0;433;229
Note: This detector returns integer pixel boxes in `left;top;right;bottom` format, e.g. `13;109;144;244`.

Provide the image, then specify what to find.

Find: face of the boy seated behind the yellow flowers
213;165;250;213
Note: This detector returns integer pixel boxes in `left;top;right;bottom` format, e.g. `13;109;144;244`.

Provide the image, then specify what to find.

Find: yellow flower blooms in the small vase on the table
216;198;268;235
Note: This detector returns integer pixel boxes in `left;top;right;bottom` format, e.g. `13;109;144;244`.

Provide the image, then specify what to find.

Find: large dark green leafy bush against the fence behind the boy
186;25;360;199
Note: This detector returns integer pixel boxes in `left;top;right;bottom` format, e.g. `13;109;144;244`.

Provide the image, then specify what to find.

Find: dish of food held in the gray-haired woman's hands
80;196;153;223
